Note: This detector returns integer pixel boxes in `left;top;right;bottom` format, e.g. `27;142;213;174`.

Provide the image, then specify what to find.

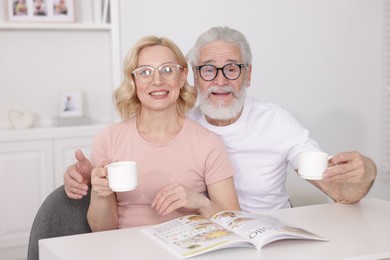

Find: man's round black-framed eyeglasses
196;63;245;81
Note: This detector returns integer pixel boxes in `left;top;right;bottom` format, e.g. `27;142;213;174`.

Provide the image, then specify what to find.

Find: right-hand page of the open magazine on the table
212;211;327;249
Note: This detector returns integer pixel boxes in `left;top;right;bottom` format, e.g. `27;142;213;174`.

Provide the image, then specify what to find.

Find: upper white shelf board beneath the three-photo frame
0;23;111;31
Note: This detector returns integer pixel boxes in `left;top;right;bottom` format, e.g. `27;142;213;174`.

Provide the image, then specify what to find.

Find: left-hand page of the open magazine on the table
143;215;254;258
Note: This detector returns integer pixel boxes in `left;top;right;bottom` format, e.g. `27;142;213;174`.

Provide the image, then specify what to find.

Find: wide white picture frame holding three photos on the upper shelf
6;0;75;22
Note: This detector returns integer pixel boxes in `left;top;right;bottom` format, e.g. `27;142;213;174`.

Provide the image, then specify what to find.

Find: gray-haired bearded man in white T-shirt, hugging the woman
64;27;376;212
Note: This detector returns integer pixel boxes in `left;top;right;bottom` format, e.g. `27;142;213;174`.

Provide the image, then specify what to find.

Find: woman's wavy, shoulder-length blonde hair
113;36;196;120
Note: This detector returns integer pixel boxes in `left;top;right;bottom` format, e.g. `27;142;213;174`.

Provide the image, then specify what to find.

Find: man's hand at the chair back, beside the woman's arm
64;150;92;199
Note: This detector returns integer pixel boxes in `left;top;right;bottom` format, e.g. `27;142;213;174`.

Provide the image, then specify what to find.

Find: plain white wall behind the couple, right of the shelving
120;0;390;200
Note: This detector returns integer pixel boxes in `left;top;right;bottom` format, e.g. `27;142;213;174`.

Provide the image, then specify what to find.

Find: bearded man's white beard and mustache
198;86;246;120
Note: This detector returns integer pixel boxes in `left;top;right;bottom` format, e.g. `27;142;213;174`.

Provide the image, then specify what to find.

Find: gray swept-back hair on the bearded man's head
187;26;252;67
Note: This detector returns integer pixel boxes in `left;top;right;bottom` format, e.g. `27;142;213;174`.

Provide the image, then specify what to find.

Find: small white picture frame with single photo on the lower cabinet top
60;92;83;117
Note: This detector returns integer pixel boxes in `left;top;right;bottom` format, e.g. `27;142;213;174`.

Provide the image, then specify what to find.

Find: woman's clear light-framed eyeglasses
131;63;182;83
